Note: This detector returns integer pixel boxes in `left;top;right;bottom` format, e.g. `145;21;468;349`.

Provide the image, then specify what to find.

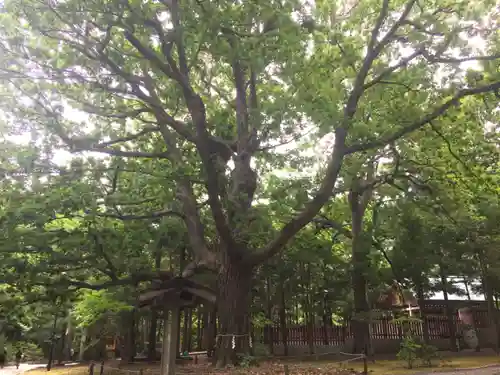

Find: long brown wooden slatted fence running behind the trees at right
261;311;488;346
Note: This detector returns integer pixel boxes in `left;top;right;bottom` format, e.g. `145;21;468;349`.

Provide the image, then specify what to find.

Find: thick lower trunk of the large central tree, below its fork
215;259;253;367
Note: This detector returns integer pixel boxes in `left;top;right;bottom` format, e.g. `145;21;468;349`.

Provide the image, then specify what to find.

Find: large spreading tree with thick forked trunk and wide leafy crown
0;0;500;365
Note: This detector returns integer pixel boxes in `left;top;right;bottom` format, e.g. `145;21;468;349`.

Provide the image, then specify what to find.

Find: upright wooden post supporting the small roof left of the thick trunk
161;306;179;375
